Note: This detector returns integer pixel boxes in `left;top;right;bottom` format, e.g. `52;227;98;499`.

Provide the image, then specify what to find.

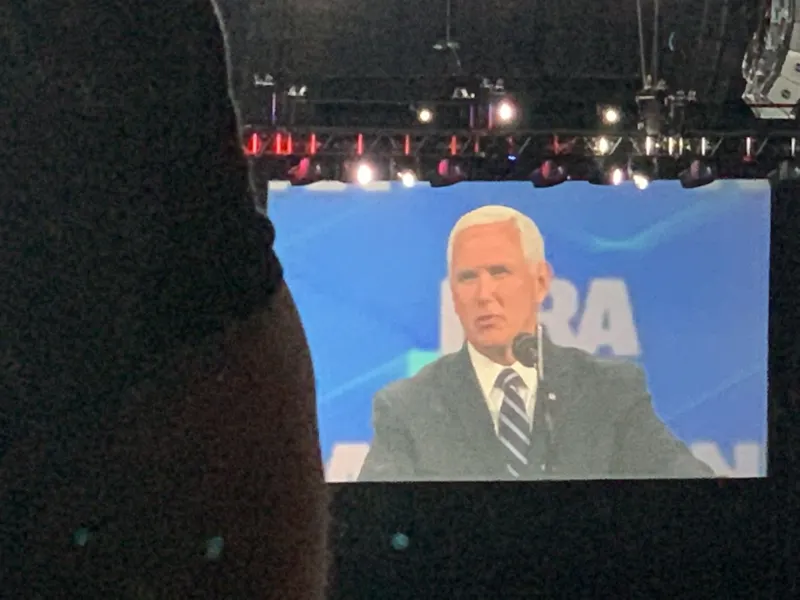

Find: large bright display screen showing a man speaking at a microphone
269;181;770;482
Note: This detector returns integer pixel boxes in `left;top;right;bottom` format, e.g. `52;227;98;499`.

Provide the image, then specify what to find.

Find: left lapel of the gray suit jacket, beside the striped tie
442;345;504;475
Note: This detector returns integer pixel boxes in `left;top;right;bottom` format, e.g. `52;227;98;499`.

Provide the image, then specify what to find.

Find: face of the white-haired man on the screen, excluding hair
450;220;552;362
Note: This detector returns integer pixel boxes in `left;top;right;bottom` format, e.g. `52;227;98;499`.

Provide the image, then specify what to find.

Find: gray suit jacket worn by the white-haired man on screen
359;340;714;481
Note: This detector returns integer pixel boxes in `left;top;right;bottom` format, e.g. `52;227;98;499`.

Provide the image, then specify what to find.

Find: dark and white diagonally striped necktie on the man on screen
495;369;531;479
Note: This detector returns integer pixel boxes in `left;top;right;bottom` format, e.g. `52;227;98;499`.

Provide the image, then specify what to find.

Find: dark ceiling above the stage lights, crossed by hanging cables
219;0;759;123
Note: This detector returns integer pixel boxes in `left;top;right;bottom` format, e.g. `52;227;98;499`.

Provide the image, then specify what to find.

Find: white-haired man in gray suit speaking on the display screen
359;206;714;481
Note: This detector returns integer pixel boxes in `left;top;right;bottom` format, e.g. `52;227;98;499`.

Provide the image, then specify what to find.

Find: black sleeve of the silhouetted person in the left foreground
0;0;268;412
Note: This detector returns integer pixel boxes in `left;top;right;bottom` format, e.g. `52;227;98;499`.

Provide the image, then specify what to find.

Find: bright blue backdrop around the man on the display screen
269;181;770;474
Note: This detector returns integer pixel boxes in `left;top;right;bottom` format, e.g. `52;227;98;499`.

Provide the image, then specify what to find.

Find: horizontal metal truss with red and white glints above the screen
243;126;800;161
